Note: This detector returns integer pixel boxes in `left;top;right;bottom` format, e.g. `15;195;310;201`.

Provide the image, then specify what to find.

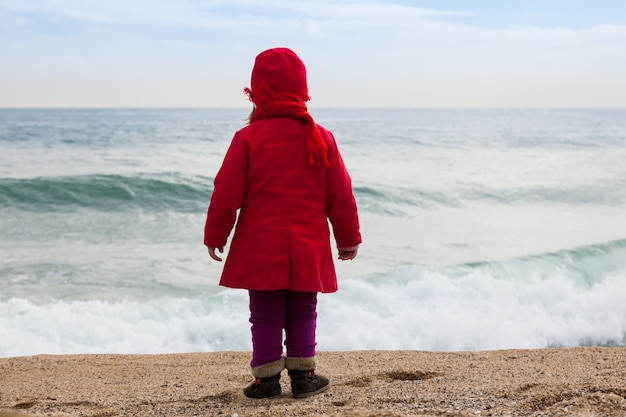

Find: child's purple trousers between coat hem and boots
249;290;317;368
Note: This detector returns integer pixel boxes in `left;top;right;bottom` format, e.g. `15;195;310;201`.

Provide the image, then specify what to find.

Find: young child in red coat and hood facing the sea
204;48;361;398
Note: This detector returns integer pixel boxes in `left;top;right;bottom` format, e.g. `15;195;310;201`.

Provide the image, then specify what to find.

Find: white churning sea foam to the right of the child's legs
319;267;626;351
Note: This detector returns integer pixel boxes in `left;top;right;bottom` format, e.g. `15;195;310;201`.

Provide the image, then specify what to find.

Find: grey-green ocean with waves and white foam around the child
0;108;626;357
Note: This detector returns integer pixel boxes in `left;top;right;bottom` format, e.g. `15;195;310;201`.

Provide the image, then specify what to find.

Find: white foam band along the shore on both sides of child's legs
0;254;626;356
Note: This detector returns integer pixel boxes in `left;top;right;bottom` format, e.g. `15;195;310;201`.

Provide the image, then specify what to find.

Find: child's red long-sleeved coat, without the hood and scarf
204;117;361;292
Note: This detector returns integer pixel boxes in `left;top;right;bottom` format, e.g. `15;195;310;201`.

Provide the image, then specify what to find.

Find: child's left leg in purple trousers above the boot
249;290;286;368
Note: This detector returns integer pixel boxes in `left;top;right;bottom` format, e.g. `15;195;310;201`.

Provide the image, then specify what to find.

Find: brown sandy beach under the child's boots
0;347;626;417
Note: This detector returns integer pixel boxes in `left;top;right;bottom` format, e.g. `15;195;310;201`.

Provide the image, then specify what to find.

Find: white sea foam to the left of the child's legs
0;291;249;356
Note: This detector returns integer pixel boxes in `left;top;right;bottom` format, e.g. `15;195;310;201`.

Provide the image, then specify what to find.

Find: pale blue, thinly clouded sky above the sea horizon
0;0;626;108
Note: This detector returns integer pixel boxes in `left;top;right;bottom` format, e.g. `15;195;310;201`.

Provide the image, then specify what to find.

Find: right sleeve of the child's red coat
324;130;362;248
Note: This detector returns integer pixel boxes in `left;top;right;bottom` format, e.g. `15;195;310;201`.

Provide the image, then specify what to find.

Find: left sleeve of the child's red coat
204;132;248;248
